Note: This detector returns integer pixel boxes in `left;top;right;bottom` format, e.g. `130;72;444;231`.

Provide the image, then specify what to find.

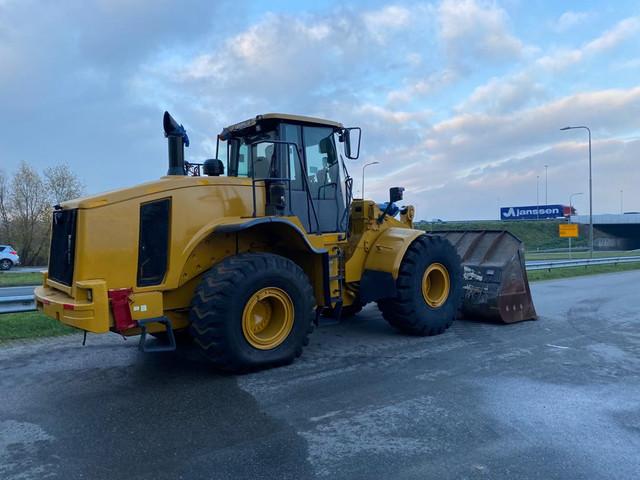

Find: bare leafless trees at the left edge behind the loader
0;162;84;265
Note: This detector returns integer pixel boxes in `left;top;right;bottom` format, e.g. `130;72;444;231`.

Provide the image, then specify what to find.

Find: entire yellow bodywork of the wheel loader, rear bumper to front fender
35;176;423;335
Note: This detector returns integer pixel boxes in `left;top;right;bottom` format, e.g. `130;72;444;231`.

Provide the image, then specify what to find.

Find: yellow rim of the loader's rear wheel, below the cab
242;287;293;350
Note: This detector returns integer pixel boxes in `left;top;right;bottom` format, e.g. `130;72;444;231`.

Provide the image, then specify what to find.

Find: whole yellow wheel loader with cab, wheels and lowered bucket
35;112;535;371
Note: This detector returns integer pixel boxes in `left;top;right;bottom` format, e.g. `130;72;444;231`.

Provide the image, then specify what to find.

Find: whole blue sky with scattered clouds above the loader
0;0;640;219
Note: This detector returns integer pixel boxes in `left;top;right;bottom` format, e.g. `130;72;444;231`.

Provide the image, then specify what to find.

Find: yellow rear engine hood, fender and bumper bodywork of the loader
36;177;352;333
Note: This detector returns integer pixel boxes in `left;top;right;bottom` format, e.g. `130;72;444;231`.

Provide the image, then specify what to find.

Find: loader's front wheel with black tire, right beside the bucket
378;235;462;336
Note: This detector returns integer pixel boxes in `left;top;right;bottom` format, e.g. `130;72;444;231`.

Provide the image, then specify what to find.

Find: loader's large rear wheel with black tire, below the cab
190;253;315;371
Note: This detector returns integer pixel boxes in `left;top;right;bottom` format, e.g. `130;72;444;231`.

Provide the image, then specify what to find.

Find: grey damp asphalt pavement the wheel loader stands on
0;271;640;480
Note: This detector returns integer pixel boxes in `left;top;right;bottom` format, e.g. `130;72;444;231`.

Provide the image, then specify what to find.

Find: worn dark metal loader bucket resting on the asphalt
433;230;537;323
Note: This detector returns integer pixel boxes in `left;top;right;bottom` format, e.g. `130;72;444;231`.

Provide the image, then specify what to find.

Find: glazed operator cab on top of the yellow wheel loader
216;113;360;233
